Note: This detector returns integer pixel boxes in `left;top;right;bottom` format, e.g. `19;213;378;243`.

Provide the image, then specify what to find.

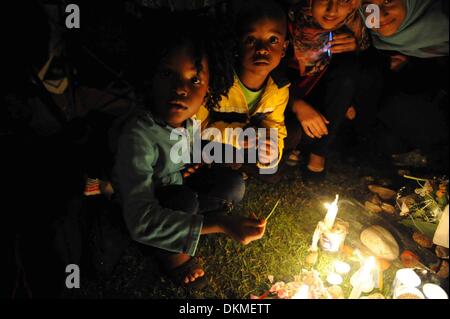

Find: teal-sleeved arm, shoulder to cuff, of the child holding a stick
116;121;203;255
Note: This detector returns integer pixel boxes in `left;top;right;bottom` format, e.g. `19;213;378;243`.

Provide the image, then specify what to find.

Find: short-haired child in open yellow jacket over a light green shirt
197;1;289;172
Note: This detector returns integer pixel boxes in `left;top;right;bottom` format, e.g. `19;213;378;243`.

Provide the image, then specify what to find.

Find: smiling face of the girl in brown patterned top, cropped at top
312;0;357;30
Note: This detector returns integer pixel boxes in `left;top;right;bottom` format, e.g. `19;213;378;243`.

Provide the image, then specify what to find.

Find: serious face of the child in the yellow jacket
239;18;288;76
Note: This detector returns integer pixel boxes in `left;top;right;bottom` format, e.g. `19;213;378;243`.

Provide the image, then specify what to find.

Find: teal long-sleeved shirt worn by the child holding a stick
114;110;203;256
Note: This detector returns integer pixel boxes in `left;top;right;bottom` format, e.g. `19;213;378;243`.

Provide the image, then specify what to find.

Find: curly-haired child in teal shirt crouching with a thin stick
115;15;265;286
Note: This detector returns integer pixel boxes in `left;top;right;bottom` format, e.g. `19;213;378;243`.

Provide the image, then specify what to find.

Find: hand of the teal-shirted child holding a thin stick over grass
224;216;266;245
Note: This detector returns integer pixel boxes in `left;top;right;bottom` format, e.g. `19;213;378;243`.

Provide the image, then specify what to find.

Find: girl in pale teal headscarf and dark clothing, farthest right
362;0;449;171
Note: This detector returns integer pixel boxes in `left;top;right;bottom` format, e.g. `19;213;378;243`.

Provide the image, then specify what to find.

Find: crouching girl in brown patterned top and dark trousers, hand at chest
287;0;369;180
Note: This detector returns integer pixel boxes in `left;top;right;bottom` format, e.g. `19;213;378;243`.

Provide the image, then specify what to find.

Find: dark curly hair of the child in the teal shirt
129;13;234;110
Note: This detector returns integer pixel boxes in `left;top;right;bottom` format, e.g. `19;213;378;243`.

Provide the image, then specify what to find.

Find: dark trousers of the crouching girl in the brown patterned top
285;50;382;157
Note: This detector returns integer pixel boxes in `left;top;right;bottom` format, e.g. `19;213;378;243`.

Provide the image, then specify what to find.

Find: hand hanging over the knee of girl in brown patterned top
293;100;330;139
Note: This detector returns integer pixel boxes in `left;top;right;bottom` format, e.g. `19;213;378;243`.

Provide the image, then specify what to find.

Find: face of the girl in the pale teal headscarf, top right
363;0;406;37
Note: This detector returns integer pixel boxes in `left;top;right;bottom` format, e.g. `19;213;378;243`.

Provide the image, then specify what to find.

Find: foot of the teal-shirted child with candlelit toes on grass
160;254;205;285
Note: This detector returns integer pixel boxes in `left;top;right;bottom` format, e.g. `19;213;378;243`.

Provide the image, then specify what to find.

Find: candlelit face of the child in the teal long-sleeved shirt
152;46;209;127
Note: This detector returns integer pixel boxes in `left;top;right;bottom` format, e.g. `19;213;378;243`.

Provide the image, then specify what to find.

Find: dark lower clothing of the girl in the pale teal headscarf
375;54;449;171
